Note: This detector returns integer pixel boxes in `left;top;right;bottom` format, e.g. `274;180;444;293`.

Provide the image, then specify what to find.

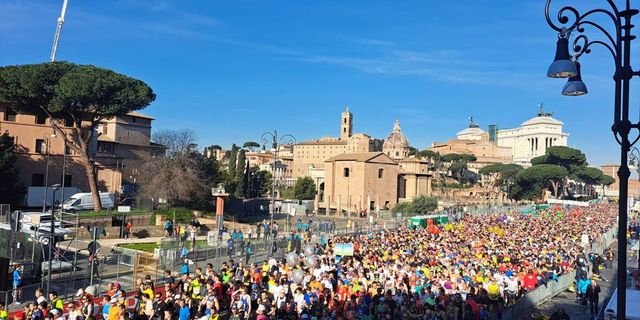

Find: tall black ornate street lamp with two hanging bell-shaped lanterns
545;0;640;319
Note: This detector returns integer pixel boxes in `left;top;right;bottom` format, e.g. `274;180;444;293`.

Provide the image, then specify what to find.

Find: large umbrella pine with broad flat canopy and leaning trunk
0;62;156;211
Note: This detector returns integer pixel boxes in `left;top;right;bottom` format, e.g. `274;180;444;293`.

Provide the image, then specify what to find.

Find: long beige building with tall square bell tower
291;108;382;179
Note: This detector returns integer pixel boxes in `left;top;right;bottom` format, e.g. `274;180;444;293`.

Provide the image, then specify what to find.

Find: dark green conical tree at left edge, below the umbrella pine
0;132;24;205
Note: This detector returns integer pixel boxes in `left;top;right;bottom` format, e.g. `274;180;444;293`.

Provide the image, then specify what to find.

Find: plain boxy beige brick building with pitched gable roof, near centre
319;152;398;214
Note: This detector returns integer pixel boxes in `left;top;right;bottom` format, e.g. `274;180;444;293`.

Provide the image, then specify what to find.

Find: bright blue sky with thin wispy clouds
0;0;624;164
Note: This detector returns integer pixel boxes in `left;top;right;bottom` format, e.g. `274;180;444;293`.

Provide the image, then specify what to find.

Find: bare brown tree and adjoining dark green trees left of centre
141;130;271;208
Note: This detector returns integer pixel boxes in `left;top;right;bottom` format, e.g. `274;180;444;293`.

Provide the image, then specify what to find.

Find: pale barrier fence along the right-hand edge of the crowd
502;227;617;320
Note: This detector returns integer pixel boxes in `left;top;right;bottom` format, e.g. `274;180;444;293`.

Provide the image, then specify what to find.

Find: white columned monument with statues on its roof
497;104;569;167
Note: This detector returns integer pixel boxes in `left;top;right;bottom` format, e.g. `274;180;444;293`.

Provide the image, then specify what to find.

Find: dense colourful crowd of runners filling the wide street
6;205;617;320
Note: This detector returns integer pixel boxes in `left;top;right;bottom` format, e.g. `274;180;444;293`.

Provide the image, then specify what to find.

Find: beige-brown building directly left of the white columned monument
429;120;513;173
